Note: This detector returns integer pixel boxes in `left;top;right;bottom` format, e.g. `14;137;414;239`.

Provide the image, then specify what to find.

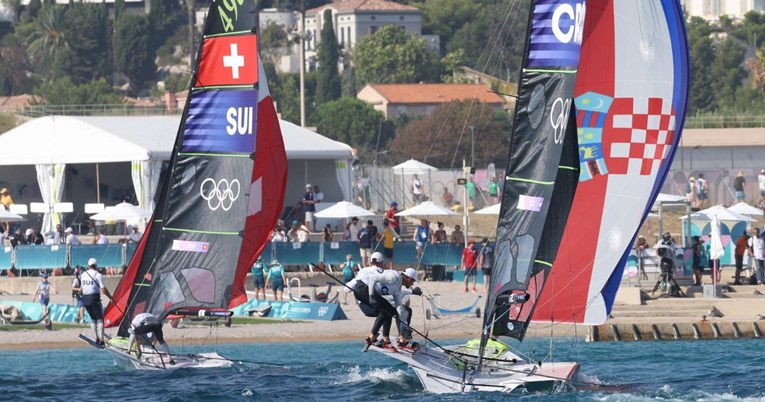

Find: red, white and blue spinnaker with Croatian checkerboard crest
533;0;690;324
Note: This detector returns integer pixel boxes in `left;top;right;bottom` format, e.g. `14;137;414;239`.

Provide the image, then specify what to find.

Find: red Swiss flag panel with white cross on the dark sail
194;35;258;87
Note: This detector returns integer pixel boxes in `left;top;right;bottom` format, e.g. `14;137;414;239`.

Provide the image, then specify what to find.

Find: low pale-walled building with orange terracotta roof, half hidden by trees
356;84;505;118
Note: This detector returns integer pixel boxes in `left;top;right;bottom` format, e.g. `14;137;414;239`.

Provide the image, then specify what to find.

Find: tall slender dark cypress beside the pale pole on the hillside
316;9;341;105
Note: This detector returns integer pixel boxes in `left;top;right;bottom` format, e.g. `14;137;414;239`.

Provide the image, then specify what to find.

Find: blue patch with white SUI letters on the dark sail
181;89;258;154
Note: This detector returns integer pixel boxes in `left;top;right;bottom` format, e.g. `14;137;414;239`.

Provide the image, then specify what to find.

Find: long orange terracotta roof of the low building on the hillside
369;84;505;104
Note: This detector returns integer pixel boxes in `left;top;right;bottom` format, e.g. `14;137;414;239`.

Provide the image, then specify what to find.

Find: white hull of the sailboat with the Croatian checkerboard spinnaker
370;346;579;394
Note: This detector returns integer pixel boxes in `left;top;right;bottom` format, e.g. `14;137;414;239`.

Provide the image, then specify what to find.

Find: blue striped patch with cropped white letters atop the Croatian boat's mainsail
528;0;585;68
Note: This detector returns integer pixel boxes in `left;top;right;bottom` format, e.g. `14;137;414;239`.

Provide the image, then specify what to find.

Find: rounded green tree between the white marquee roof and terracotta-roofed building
316;98;385;158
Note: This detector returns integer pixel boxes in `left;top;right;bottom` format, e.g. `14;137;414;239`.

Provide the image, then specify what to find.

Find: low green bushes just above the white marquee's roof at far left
32;77;122;105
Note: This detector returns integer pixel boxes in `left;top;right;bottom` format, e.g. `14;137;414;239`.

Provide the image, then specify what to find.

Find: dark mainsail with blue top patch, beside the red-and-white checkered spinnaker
484;0;585;339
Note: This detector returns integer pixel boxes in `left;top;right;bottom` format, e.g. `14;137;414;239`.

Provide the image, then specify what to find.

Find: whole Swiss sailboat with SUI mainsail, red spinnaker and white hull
81;0;287;369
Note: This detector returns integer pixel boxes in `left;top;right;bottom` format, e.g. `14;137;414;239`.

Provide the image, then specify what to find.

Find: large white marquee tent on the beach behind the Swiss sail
0;116;353;230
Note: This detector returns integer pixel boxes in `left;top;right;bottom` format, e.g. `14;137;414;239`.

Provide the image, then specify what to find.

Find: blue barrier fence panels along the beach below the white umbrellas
0;241;466;270
